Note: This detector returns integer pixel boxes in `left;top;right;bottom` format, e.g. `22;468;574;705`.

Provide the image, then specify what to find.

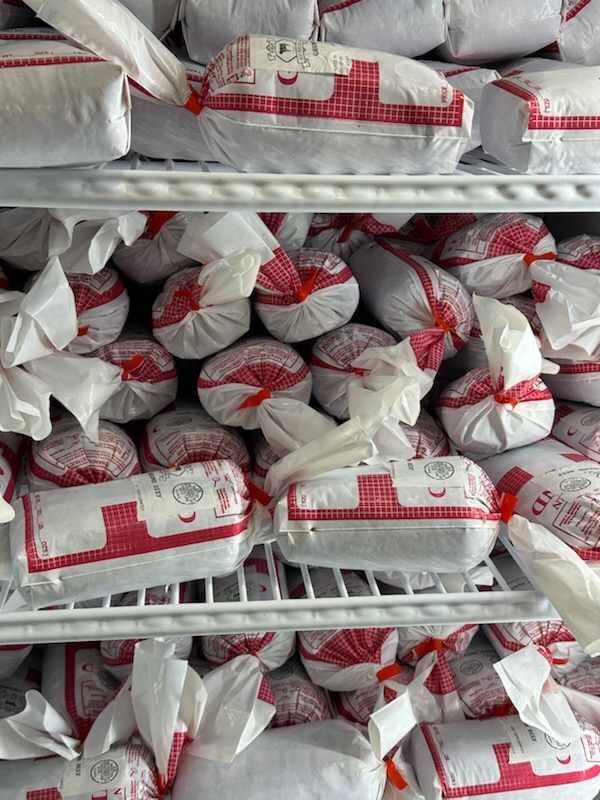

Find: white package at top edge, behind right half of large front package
319;0;446;58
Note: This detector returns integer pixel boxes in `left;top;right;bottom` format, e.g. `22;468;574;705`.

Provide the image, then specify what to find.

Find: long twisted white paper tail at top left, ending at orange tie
25;0;191;109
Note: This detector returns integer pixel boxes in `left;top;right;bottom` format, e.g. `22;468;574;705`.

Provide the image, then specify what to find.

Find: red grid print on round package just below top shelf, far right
431;214;550;269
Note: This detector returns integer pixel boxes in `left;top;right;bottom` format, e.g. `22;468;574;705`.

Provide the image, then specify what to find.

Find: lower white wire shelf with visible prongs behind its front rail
0;539;558;644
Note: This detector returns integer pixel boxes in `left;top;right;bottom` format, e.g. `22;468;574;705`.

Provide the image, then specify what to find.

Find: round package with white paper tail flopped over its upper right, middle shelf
152;250;260;359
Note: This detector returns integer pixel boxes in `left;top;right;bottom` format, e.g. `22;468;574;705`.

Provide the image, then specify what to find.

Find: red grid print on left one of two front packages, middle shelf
22;493;249;573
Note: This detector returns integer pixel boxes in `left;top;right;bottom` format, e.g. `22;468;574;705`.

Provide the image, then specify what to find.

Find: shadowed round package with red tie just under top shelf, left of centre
112;211;194;284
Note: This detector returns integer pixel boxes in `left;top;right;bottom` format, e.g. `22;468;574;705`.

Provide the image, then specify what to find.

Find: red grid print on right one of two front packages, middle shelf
287;474;500;521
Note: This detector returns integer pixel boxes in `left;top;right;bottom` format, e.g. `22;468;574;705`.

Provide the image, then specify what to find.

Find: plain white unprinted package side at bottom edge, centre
170;720;386;800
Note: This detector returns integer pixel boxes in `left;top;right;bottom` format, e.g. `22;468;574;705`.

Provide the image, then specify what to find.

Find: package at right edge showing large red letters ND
480;439;600;561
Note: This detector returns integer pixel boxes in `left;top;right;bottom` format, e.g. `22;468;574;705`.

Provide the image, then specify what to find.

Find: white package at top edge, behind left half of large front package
183;0;318;64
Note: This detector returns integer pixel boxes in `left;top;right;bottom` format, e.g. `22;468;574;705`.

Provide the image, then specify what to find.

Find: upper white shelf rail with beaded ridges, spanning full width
0;151;600;213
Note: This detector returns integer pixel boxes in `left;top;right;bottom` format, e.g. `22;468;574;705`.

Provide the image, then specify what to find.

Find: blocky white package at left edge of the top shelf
0;40;130;167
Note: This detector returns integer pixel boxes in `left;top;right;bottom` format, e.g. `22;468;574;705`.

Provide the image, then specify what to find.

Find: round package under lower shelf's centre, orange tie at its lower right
290;569;398;692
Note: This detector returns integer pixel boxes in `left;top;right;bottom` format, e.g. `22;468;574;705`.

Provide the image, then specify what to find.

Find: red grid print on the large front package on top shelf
203;60;464;128
